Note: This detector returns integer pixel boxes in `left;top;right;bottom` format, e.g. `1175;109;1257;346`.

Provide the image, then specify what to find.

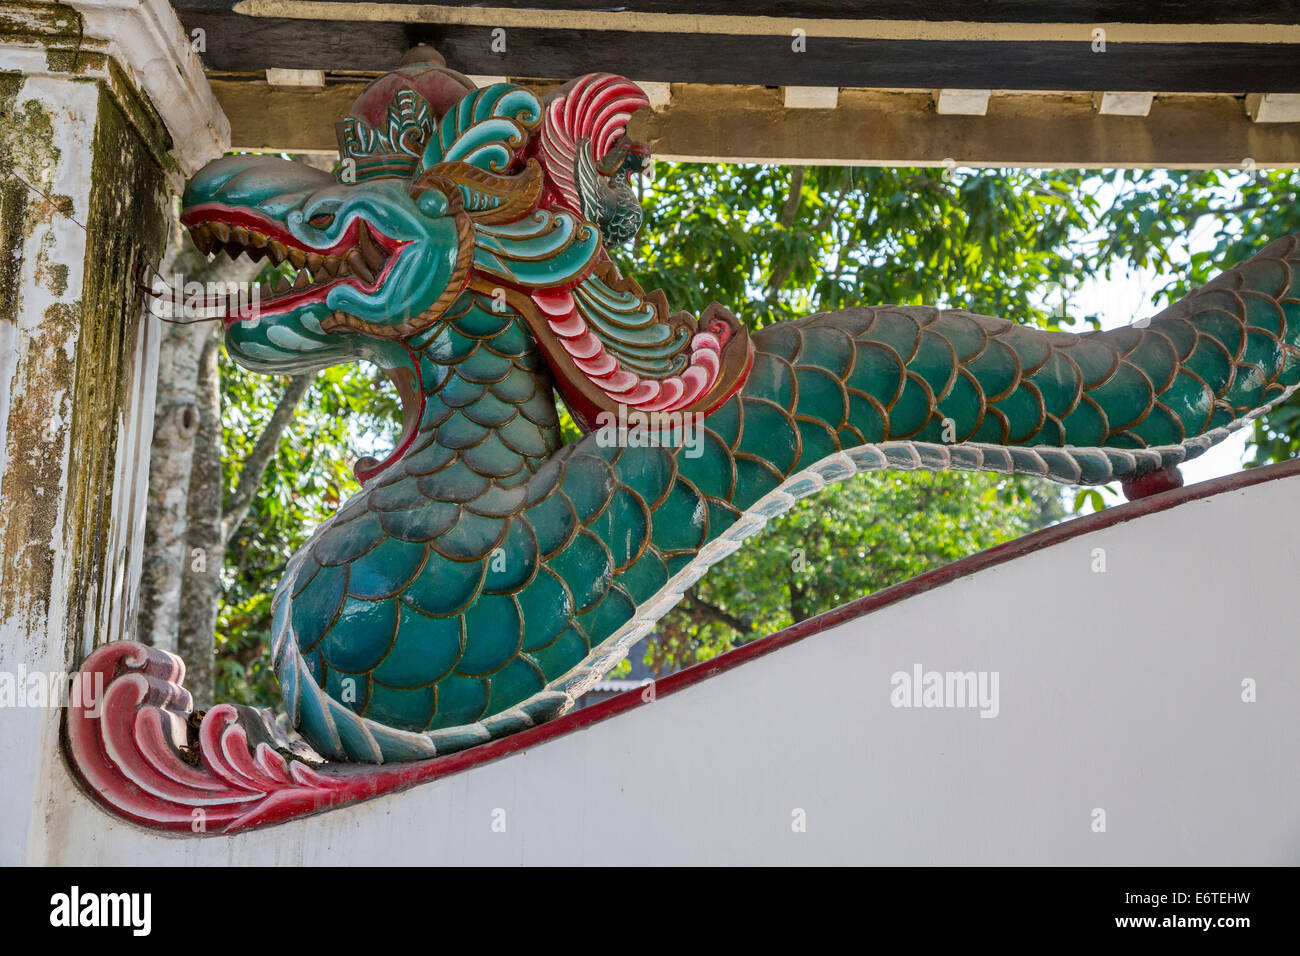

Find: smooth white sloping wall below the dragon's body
32;477;1300;865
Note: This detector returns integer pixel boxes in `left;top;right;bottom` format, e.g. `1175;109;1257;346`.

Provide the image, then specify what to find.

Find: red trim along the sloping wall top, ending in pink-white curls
65;460;1300;834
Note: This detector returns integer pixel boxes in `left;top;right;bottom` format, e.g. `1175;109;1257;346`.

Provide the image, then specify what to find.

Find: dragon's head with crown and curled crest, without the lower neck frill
182;47;646;372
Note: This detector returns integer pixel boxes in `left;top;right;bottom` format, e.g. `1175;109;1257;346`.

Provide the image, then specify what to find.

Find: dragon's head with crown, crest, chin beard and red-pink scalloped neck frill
181;48;750;480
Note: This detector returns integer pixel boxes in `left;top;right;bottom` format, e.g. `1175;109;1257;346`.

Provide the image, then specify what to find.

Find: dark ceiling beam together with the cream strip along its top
176;0;1300;94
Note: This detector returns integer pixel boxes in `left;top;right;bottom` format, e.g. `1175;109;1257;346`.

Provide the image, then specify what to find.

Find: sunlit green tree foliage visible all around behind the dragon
218;163;1300;704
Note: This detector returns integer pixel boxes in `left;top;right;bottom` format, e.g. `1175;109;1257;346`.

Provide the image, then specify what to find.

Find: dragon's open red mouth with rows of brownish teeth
181;204;404;324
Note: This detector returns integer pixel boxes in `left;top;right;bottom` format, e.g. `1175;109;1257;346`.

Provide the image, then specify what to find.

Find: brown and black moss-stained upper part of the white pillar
0;18;178;663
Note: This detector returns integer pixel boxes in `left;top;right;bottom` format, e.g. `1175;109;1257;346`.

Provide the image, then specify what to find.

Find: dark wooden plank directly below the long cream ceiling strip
185;12;1300;92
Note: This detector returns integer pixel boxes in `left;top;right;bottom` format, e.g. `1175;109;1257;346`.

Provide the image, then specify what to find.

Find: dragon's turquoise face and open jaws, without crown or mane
182;156;472;372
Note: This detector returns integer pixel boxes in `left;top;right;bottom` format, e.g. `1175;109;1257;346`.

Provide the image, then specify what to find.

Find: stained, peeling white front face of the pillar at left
0;70;98;864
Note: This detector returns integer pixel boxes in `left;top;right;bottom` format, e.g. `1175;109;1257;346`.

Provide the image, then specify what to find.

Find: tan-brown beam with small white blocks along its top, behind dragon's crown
212;77;1300;169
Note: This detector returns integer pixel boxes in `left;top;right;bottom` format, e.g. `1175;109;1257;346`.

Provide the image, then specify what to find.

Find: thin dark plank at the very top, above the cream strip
174;0;1300;23
